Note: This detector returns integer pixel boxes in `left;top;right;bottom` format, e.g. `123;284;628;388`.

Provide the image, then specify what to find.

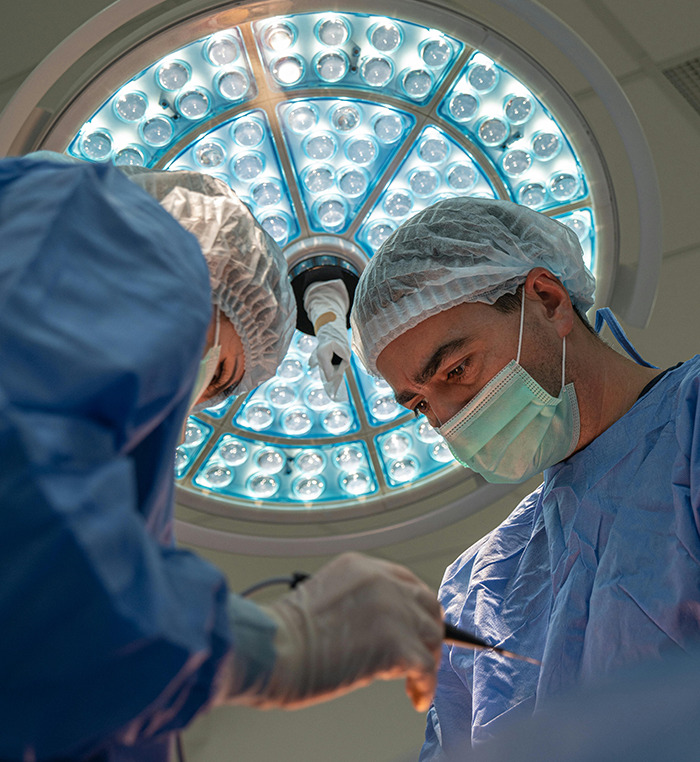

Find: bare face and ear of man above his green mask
377;286;561;427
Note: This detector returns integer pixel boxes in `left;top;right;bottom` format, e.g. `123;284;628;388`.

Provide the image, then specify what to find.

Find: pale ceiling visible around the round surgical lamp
0;0;700;762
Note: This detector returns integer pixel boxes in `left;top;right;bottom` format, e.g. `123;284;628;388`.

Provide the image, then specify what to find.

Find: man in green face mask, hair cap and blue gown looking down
352;198;700;760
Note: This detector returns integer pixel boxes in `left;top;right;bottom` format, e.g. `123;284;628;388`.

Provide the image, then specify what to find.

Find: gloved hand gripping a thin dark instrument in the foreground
224;553;443;711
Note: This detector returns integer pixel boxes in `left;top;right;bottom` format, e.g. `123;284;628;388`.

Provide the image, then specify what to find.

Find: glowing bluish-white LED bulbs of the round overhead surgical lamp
68;13;595;508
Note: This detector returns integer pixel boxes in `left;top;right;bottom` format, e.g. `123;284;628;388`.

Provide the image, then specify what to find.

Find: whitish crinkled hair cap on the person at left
121;168;296;392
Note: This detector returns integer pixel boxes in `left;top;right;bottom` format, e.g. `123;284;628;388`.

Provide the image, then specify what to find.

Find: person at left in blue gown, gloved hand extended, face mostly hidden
0;156;442;762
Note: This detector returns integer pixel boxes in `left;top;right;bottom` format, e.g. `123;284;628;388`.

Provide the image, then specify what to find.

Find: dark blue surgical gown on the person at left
0;158;231;761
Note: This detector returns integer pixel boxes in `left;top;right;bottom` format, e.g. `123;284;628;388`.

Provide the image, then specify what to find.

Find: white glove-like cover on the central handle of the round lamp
304;279;352;400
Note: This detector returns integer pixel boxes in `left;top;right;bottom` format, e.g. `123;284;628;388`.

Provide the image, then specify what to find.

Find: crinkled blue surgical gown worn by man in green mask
420;356;700;762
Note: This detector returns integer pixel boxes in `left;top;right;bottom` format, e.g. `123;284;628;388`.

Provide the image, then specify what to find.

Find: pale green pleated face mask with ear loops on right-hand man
438;293;580;483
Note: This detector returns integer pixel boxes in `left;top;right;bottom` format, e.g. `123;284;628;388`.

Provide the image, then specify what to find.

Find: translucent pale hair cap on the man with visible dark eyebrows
351;197;595;373
